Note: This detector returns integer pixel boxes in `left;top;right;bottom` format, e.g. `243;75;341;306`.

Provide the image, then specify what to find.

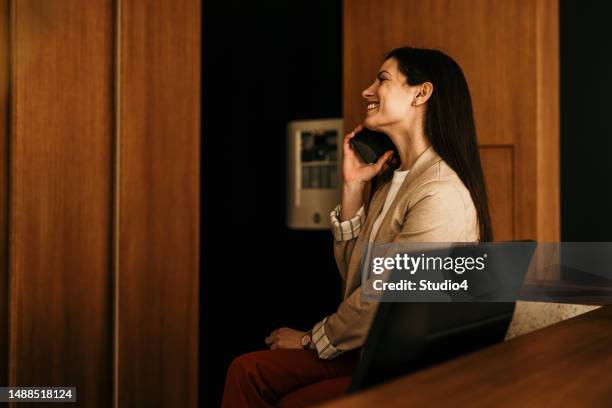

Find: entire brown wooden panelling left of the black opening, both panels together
0;0;200;407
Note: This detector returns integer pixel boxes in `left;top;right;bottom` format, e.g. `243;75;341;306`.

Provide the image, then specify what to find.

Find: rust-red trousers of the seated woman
222;349;359;408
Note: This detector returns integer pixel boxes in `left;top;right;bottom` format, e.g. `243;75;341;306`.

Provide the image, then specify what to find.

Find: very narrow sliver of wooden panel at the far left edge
0;0;10;387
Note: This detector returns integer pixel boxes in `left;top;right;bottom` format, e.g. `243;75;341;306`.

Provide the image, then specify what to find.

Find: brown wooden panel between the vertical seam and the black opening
116;0;201;407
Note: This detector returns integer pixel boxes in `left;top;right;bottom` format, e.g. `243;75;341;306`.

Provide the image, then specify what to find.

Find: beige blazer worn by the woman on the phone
324;147;479;351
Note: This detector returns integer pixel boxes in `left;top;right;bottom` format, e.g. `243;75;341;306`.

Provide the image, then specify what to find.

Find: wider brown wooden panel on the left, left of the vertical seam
9;0;113;408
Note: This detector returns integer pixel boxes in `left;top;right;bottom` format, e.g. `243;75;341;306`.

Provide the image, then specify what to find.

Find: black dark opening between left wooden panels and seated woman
200;0;342;407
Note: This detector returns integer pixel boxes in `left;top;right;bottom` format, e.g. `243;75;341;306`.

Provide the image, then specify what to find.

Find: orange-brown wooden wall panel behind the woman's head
343;0;559;241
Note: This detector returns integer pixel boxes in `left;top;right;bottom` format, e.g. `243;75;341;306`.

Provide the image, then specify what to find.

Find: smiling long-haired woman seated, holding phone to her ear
223;47;492;407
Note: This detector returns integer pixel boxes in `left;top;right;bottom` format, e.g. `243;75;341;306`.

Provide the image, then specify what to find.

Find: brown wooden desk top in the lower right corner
324;305;612;408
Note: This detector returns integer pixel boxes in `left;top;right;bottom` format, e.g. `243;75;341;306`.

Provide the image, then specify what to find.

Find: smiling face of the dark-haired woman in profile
361;58;420;131
